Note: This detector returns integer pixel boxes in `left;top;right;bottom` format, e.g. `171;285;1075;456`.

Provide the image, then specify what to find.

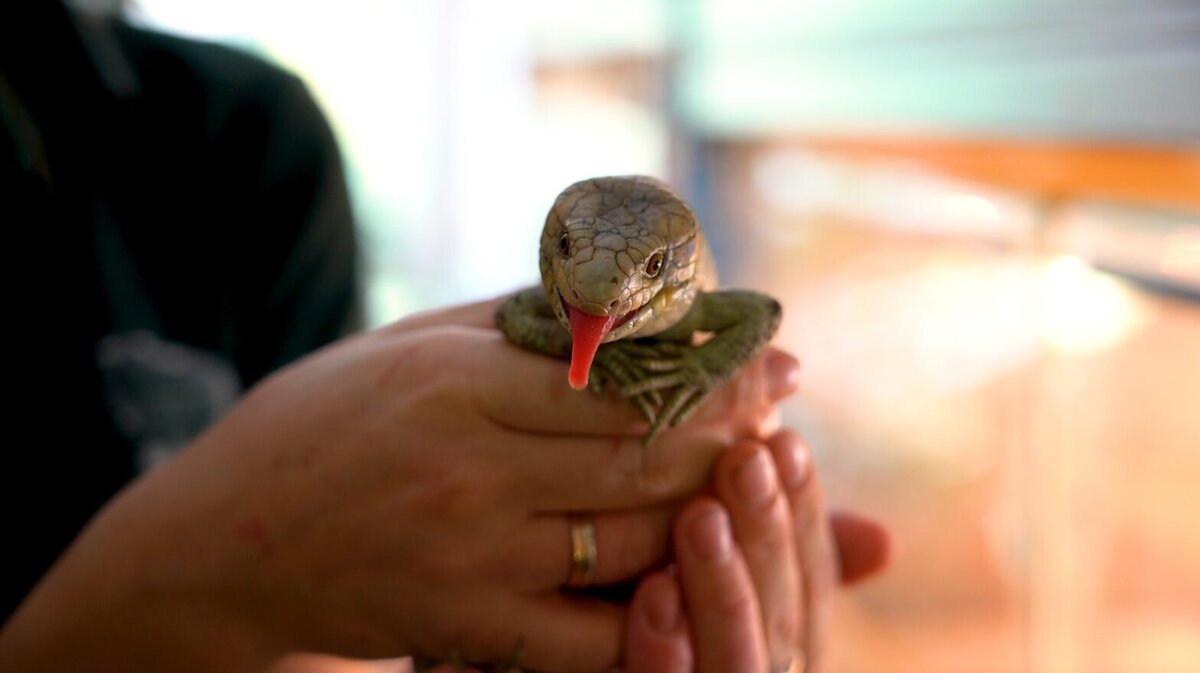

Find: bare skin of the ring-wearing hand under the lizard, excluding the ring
0;302;796;672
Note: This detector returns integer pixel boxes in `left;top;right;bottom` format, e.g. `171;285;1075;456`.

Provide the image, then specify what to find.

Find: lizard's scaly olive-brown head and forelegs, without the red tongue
496;175;781;445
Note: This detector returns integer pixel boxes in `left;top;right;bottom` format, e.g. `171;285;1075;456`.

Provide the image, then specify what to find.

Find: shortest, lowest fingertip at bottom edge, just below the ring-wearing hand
624;571;695;673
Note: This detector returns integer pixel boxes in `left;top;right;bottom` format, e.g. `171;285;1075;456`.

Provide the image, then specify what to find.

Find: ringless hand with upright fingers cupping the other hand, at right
625;431;888;673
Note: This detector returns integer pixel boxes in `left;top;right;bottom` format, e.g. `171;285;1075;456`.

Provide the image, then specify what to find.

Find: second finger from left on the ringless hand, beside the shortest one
674;497;770;673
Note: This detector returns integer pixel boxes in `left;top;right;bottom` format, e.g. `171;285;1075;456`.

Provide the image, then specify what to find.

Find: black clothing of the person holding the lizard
0;0;358;623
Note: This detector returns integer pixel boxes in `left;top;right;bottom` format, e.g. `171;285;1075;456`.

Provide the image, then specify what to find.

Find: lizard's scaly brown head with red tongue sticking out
540;176;708;390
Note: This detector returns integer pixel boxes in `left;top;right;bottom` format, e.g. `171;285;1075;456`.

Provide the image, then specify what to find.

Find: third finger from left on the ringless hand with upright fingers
715;440;802;669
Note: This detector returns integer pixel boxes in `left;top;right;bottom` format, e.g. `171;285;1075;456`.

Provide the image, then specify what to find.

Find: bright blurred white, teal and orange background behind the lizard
132;0;1200;673
